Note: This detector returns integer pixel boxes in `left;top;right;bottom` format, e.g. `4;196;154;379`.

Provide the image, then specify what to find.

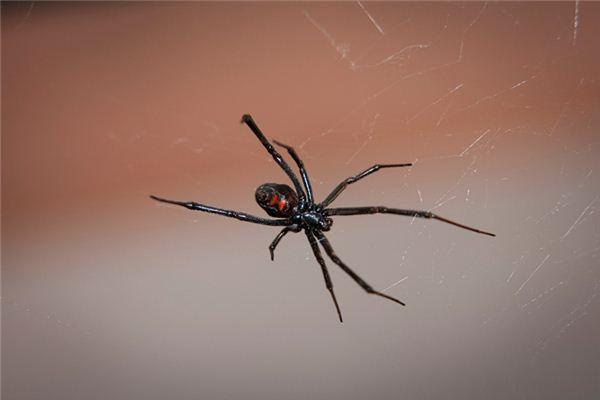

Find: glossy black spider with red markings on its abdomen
150;114;496;322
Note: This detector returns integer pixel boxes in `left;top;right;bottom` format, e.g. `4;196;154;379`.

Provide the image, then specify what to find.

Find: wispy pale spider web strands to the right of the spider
302;2;600;363
